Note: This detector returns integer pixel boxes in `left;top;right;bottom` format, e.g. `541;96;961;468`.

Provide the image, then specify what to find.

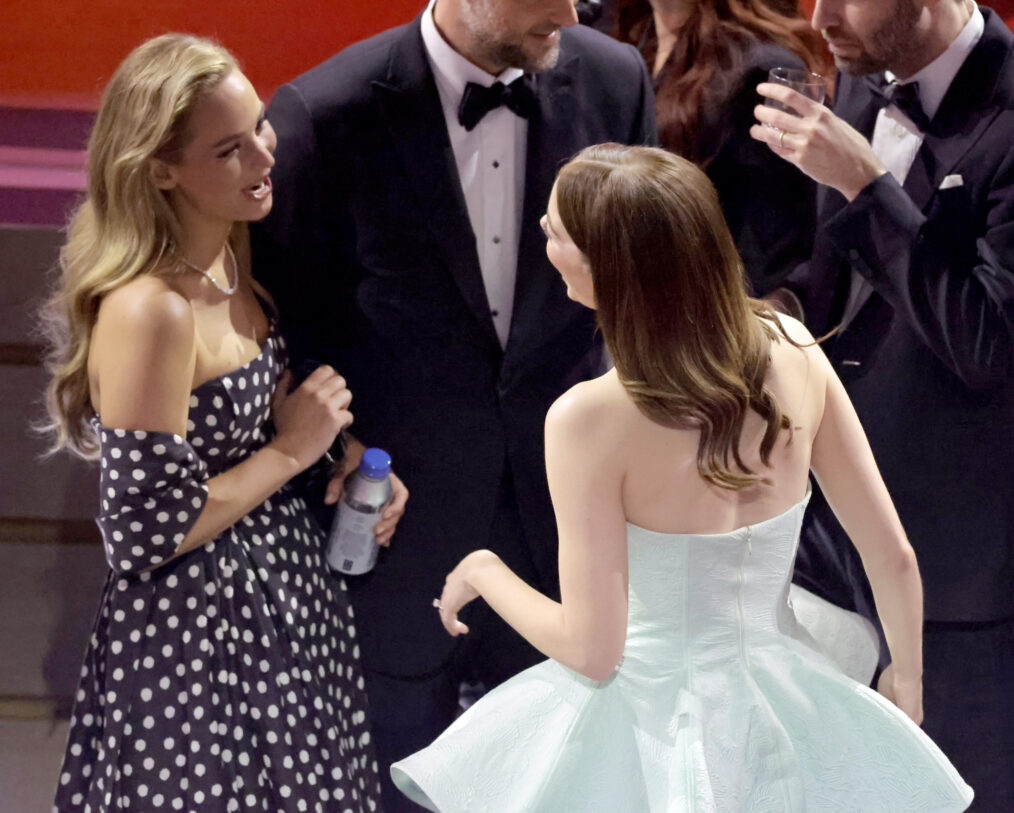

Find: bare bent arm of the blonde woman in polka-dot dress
92;286;352;570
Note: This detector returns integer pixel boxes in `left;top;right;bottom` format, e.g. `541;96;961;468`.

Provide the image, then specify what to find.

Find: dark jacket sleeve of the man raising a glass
826;147;1014;387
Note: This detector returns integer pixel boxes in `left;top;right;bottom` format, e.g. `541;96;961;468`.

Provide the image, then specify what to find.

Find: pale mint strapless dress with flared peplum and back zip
391;490;972;813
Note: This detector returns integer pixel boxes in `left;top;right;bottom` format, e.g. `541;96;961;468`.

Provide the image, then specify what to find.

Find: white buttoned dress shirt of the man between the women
422;0;528;347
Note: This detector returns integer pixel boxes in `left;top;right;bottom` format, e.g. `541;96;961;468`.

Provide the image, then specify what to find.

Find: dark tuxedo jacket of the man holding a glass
792;8;1014;621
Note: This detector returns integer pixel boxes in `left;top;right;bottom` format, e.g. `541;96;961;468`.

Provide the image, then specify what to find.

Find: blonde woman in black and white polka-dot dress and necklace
47;34;401;811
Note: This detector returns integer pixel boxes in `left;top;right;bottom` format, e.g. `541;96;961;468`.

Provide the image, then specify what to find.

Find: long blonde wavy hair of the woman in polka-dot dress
42;33;245;458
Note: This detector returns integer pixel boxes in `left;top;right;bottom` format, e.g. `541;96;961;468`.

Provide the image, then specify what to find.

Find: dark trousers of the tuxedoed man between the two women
364;468;545;813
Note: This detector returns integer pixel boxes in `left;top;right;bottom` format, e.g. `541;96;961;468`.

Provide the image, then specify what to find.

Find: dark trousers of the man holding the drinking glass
793;492;1014;813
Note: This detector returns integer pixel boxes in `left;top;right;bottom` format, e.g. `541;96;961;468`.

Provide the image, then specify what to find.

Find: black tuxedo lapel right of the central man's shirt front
507;49;587;357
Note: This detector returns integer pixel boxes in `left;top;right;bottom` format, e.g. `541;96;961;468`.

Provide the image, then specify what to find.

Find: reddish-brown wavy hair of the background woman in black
613;0;827;163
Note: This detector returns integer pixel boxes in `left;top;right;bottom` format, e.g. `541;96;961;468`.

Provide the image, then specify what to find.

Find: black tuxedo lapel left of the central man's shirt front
373;18;500;350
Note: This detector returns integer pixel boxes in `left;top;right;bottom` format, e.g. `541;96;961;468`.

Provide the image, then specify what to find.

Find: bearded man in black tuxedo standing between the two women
254;0;656;810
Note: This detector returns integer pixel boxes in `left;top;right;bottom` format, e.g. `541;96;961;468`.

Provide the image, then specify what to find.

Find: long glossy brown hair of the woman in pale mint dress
557;144;790;489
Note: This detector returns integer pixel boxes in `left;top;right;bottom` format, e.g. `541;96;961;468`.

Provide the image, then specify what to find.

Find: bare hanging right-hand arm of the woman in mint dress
808;348;923;723
